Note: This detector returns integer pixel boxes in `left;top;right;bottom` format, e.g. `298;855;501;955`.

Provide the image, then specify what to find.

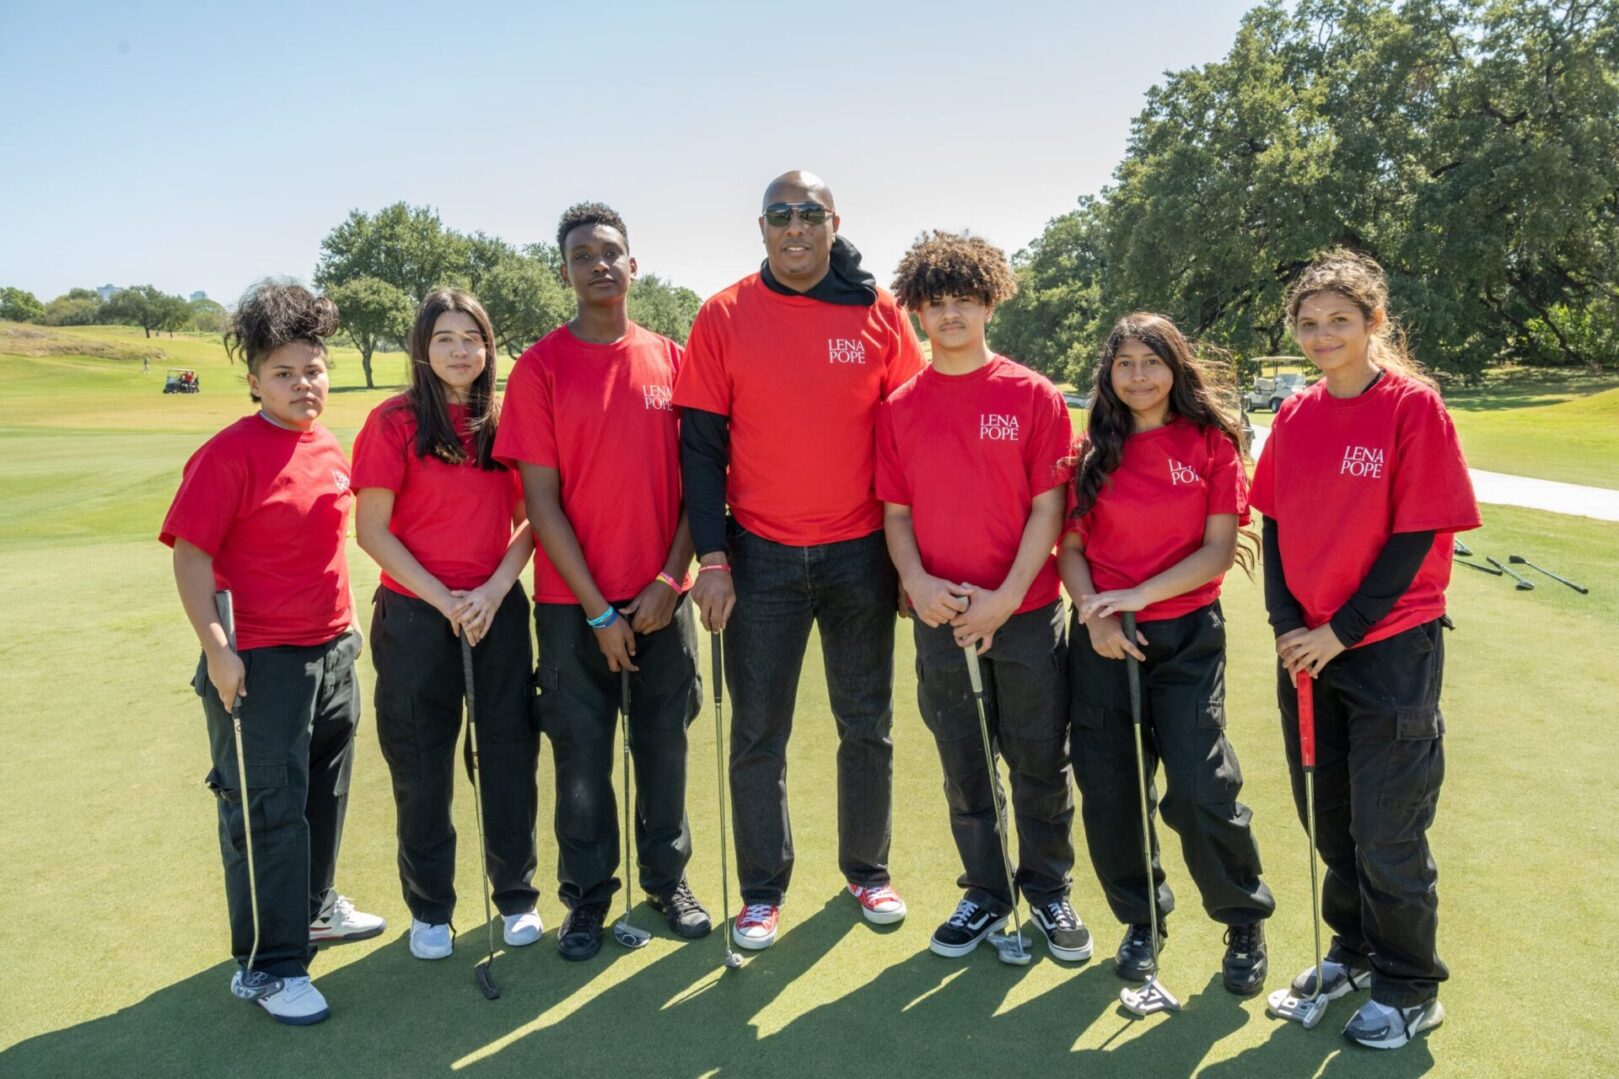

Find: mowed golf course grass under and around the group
0;329;1619;1076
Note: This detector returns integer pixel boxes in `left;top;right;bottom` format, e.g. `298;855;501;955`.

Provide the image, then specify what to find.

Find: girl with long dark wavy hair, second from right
1059;313;1276;995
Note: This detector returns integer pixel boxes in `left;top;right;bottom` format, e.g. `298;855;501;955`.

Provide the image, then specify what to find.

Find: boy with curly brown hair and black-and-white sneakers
877;232;1091;962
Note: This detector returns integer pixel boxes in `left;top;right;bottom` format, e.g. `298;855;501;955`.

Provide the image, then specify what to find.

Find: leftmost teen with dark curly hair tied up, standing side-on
159;282;385;1026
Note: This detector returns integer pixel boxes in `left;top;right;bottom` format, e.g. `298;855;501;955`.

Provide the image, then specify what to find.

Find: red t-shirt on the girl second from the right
1067;416;1248;622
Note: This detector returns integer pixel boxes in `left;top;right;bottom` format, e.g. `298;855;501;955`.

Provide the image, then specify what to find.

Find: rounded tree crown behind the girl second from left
314;203;469;303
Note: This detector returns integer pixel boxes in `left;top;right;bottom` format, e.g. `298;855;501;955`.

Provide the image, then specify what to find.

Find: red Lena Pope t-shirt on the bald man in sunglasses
675;274;923;548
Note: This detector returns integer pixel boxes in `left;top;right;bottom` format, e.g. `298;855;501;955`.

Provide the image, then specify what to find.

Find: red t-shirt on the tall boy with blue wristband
495;322;680;603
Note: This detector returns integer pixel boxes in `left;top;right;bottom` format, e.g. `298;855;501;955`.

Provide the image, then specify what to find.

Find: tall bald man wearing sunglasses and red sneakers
674;172;923;949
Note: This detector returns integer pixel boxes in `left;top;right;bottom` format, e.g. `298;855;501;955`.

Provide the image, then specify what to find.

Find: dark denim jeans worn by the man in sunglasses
725;522;899;904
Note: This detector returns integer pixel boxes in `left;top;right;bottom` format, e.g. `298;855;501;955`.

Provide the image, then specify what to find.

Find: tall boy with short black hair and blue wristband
495;203;711;959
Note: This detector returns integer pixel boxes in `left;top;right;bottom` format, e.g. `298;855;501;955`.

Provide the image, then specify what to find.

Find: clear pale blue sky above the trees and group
0;0;1251;303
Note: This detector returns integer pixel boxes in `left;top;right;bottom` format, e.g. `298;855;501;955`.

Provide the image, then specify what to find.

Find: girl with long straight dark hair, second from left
355;288;541;959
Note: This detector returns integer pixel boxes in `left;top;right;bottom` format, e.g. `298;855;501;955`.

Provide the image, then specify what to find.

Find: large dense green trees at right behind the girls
991;0;1619;381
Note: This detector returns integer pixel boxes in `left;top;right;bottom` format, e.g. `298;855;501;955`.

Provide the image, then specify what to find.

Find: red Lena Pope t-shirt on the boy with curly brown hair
877;356;1073;614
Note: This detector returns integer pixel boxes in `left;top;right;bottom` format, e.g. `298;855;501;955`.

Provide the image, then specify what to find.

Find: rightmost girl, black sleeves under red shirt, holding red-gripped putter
1253;249;1480;1048
